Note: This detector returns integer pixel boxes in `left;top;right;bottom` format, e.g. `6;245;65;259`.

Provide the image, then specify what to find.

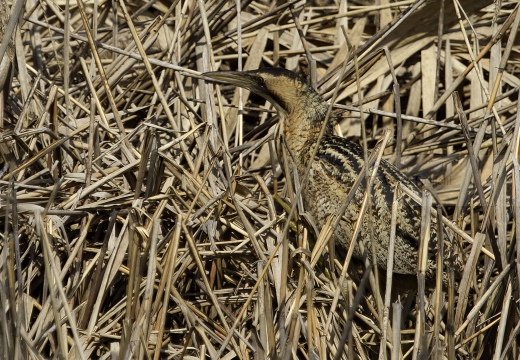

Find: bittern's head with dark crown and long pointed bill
203;68;322;114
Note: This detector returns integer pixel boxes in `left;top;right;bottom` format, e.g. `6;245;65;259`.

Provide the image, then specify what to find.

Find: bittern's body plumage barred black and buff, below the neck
296;136;461;281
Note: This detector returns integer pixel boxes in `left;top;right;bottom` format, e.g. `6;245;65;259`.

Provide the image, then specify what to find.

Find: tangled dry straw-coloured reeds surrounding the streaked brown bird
0;0;520;359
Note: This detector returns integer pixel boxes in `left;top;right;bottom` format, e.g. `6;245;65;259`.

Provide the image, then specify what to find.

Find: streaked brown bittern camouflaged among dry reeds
203;68;461;284
